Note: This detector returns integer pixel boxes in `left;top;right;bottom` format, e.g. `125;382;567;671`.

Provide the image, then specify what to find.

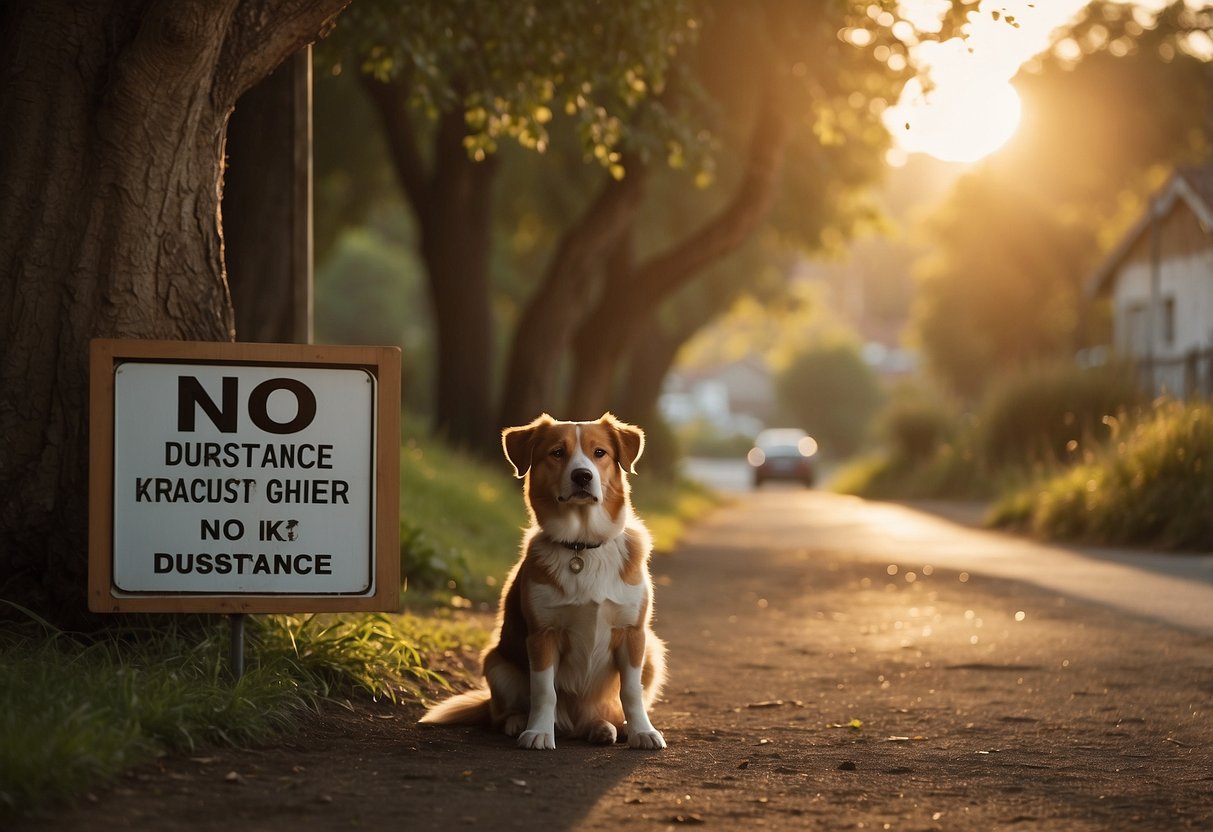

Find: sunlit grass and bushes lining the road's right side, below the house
833;378;1213;551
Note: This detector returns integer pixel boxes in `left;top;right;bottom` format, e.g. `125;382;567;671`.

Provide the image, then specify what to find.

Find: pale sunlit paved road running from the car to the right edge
688;460;1213;634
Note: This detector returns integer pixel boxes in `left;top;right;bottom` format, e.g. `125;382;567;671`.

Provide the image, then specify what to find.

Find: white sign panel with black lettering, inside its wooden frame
114;361;375;594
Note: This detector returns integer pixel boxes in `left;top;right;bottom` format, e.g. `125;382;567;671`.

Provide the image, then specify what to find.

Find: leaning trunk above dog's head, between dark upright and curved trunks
500;161;645;426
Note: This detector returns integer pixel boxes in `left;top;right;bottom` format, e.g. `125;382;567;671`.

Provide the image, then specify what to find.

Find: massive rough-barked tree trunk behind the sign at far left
0;0;344;625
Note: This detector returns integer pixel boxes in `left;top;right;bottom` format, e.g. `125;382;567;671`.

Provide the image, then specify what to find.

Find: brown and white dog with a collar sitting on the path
421;414;666;748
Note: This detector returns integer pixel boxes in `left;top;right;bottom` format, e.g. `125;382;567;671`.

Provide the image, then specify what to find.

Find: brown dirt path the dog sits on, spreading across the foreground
19;494;1213;832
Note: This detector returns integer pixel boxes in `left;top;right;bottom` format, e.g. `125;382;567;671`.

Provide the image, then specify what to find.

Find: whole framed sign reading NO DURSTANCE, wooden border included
89;340;400;614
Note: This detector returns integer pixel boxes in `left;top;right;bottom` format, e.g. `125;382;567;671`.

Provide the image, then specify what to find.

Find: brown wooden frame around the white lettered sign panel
89;340;400;614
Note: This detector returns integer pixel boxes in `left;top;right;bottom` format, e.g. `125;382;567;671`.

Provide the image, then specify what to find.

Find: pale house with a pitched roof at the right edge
1087;167;1213;397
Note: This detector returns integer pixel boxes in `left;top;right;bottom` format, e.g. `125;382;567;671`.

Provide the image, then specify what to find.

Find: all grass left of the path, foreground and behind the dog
0;414;714;825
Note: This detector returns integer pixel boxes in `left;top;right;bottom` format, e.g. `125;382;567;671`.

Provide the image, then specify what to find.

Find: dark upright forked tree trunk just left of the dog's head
361;75;497;452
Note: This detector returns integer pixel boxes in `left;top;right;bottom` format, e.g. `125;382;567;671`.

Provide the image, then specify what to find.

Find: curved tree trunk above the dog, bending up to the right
568;84;788;412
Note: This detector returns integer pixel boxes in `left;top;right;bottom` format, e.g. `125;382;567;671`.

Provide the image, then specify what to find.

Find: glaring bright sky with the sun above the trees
884;0;1087;165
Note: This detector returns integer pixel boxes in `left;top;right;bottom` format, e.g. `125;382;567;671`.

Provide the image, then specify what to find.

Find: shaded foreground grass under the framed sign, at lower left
0;615;484;819
